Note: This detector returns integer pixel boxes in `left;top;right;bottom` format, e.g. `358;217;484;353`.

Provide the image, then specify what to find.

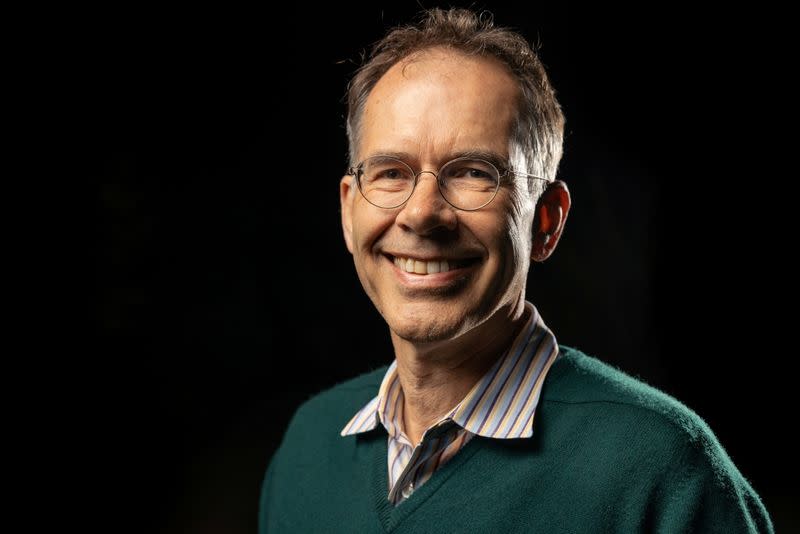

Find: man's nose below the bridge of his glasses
396;171;458;235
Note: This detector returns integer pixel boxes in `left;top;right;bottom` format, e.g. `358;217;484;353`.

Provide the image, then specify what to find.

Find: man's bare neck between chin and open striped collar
392;308;528;445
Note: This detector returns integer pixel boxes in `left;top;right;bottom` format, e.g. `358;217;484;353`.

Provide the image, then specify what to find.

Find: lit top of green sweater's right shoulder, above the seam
542;346;716;447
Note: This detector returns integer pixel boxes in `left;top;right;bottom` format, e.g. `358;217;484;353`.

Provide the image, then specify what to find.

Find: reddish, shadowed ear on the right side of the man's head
531;180;571;262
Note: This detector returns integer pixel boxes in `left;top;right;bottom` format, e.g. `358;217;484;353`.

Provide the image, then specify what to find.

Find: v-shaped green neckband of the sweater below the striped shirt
372;432;486;532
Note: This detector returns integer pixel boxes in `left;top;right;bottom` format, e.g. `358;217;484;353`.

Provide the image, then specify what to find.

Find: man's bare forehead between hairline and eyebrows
359;49;520;162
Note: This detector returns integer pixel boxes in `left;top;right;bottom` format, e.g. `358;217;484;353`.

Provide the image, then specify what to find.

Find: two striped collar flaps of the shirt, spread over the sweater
341;302;558;439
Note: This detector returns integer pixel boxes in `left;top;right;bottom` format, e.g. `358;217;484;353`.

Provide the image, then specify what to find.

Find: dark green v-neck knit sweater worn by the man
259;345;773;534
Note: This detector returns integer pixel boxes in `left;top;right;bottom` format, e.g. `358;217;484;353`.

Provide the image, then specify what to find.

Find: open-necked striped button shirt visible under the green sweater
341;302;558;505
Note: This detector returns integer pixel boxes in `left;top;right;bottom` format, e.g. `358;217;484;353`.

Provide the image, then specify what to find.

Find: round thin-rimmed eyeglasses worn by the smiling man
347;156;548;211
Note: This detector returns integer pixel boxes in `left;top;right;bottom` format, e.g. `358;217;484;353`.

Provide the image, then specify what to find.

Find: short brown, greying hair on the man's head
347;8;564;186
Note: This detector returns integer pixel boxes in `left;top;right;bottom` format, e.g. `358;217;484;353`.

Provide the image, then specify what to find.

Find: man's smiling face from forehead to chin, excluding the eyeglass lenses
341;50;535;343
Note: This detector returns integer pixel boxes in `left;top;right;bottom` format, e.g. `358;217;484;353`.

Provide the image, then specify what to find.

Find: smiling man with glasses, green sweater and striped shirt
260;9;772;532
